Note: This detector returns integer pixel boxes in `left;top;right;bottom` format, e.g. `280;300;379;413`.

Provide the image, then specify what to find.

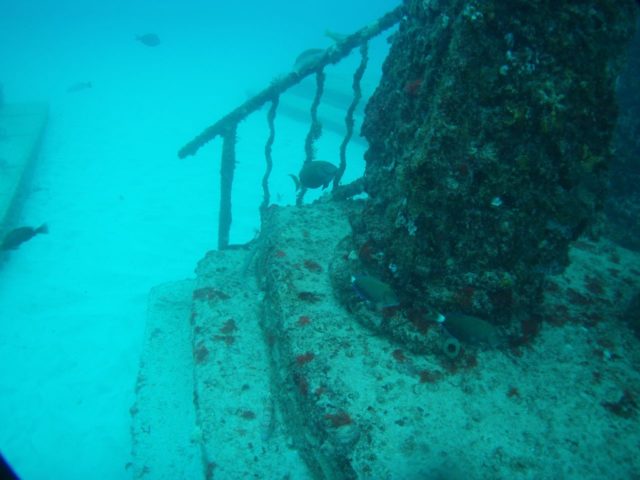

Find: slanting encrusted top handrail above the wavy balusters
178;6;404;158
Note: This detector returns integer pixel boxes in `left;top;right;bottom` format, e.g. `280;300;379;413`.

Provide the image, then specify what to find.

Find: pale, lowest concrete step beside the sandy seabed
130;280;204;480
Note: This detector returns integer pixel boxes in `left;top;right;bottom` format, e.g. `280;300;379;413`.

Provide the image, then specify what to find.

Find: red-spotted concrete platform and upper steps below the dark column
136;202;640;480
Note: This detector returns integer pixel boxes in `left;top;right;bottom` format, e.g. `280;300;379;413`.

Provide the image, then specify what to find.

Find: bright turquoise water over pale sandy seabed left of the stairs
0;0;397;479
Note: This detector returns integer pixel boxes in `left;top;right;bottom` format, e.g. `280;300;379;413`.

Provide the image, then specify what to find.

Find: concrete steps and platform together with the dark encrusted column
128;0;640;480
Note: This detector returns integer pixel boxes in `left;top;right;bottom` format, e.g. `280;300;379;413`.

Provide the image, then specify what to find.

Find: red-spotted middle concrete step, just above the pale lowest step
192;250;310;480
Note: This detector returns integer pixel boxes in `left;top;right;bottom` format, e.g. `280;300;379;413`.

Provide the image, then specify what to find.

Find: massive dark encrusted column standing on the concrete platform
353;0;637;324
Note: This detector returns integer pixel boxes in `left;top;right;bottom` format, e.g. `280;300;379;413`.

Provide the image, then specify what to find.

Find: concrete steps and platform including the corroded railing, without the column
130;4;640;480
